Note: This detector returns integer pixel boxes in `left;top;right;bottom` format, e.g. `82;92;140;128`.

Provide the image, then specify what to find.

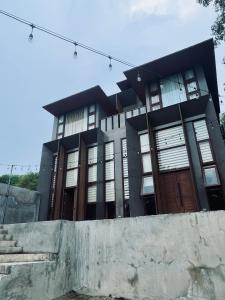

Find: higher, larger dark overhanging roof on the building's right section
121;39;220;113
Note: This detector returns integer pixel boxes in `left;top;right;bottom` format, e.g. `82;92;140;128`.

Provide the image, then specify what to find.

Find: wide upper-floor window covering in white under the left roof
64;108;87;136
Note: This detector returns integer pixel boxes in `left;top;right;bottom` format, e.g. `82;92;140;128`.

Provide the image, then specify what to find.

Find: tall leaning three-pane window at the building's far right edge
193;119;220;187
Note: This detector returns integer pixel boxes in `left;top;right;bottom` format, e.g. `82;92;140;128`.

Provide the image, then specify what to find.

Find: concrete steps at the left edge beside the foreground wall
0;225;56;280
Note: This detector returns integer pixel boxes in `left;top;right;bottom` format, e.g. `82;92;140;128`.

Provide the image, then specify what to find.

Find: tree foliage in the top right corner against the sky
197;0;225;45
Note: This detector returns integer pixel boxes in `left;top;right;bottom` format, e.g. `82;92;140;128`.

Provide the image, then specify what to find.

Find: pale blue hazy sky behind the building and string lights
0;0;225;175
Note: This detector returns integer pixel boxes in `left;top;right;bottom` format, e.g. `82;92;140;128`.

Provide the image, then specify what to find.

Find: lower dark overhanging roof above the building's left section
43;86;117;116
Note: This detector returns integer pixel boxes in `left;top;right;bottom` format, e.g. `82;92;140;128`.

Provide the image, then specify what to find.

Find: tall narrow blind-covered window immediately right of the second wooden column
87;146;98;203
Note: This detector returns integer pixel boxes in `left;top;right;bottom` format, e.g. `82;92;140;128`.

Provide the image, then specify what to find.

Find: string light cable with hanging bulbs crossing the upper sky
0;10;225;98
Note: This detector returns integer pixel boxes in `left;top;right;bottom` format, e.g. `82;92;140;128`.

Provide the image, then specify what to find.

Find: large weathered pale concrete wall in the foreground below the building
0;211;225;300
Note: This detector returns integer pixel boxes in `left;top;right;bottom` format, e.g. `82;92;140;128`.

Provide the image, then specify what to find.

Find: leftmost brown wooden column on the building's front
53;142;65;220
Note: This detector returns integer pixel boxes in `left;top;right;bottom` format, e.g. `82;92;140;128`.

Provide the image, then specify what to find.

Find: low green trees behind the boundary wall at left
0;172;38;191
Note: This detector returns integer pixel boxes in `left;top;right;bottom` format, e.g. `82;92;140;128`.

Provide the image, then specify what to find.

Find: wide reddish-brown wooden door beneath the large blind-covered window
159;170;198;213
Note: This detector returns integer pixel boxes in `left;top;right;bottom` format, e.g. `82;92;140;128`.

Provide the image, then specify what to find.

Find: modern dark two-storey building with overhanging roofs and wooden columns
39;40;225;220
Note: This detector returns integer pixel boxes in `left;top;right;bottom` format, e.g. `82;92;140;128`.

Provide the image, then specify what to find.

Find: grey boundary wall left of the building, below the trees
0;183;40;224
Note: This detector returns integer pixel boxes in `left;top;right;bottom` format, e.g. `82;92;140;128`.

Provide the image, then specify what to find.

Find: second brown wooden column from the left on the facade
77;136;87;221
